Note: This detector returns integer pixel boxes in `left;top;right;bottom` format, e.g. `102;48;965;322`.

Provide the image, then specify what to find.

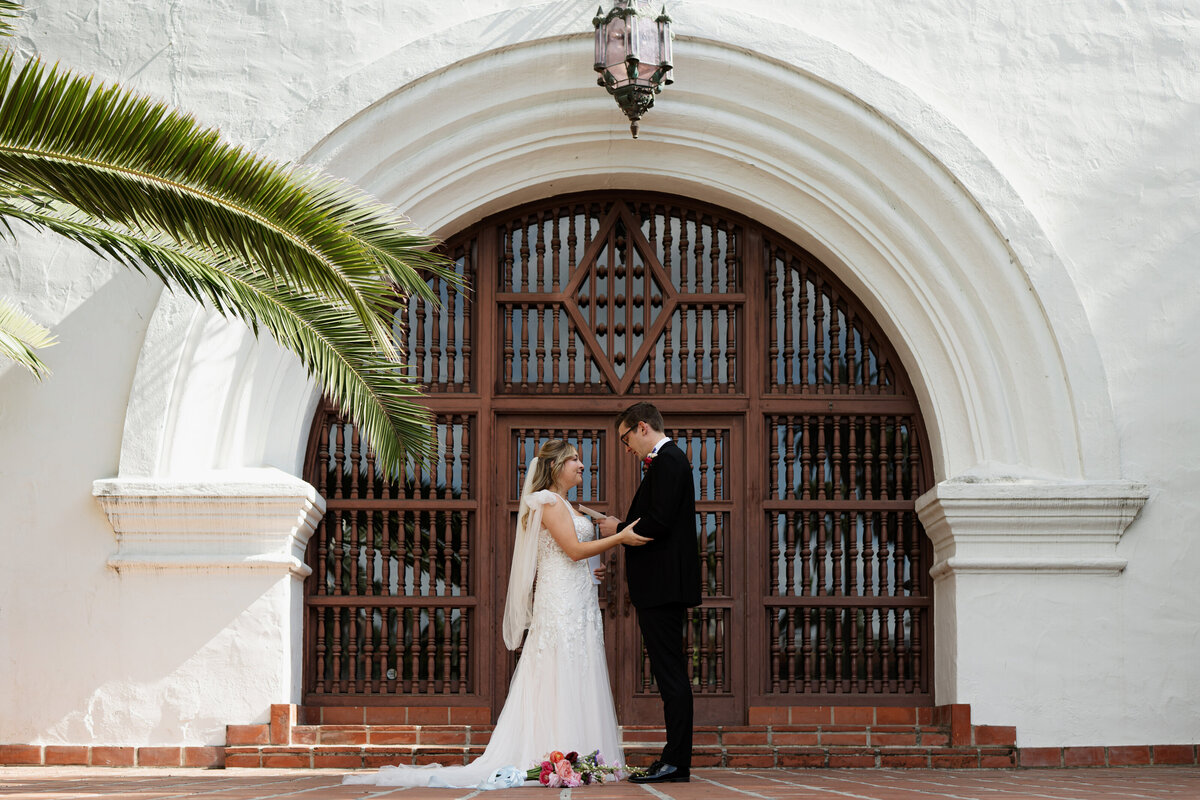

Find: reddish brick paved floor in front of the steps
0;766;1200;800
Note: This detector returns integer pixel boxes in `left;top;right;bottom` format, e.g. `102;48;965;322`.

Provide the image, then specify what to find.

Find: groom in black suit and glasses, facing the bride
600;403;700;783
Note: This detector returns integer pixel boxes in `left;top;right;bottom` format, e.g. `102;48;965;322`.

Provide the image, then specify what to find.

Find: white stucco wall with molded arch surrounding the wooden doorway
0;0;1200;746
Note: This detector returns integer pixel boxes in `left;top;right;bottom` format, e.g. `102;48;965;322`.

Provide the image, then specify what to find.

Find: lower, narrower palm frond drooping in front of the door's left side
0;197;432;476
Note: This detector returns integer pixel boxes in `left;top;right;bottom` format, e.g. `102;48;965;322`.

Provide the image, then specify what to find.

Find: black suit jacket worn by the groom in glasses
622;441;700;608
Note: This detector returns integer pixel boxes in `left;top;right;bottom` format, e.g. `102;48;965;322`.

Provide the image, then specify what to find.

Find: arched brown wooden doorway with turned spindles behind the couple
304;193;932;724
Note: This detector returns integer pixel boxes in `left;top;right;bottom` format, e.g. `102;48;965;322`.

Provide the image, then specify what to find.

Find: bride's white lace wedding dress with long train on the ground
344;491;625;788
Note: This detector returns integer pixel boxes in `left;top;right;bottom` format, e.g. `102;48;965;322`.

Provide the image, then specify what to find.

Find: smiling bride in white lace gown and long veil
344;439;650;789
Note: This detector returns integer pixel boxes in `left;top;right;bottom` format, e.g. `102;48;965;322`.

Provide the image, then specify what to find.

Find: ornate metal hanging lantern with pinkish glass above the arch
592;0;674;139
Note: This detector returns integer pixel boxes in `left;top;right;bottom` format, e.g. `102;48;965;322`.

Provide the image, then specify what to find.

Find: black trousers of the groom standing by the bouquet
637;603;692;770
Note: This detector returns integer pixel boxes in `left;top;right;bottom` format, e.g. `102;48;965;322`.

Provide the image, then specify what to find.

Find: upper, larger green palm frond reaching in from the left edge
0;54;457;357
